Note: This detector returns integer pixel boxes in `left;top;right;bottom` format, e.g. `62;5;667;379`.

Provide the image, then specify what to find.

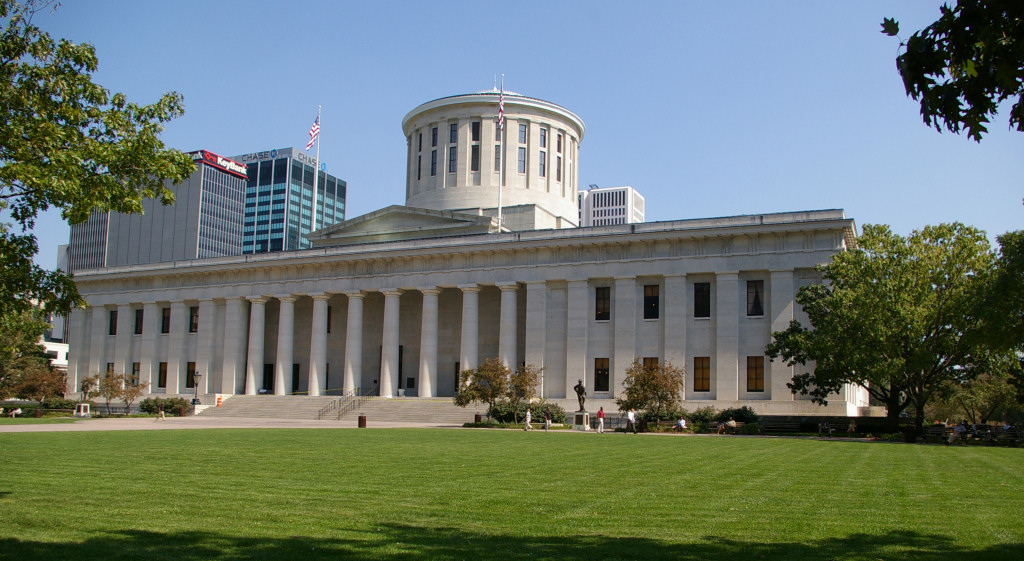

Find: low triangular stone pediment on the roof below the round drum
307;205;498;248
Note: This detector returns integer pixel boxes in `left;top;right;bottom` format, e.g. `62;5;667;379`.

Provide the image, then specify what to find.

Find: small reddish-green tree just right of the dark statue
615;358;685;420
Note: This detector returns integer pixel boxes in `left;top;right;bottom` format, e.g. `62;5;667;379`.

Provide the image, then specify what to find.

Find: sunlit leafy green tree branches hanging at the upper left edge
0;0;195;317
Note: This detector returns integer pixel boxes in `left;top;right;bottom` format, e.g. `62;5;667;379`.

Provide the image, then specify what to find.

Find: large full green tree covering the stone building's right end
766;223;993;431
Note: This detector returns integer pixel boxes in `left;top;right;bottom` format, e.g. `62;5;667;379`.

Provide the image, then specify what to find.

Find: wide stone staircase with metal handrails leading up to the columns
199;395;486;425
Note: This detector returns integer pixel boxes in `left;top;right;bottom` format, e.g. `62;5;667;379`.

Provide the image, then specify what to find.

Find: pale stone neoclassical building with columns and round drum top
69;92;867;415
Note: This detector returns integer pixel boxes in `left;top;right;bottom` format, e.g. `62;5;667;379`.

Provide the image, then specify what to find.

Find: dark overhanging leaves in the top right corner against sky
882;0;1024;141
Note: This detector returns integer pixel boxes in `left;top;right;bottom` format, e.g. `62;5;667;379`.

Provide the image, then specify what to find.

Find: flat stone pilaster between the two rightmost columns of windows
712;272;739;401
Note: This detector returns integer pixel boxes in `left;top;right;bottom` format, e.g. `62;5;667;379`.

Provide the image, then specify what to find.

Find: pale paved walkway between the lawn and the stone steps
0;416;456;432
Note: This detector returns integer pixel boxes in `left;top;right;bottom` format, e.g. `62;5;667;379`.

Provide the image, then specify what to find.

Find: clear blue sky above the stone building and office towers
28;0;1024;267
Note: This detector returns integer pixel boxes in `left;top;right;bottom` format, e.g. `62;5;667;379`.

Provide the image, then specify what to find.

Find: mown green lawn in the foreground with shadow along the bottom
0;429;1024;561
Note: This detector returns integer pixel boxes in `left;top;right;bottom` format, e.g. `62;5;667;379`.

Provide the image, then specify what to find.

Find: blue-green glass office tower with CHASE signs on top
232;148;347;253
